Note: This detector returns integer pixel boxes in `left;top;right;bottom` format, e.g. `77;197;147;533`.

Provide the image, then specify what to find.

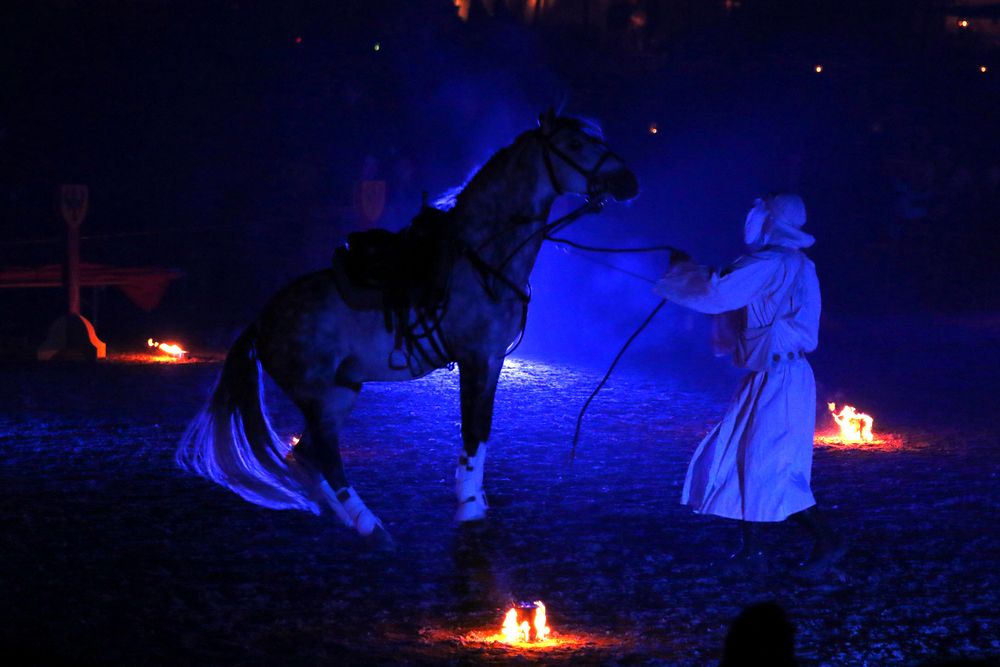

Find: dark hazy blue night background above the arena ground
0;0;1000;354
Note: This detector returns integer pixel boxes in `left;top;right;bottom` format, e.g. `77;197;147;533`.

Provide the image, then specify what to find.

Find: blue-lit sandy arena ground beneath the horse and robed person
0;325;1000;667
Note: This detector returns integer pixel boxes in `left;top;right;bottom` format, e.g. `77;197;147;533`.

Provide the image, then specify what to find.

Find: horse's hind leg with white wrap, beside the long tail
296;386;384;536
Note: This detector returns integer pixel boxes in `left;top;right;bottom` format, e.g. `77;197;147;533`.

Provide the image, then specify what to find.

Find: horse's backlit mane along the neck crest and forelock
434;116;604;218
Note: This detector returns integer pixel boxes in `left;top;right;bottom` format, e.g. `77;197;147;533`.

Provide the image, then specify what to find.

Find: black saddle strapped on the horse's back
333;206;458;369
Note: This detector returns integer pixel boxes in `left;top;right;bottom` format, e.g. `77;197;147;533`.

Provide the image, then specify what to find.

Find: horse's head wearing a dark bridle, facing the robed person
537;109;639;201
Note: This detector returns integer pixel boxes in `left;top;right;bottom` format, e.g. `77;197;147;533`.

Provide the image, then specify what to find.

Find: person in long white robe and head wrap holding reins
654;194;844;572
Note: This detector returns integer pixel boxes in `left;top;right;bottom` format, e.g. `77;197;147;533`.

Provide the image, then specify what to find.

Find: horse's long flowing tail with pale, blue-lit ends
177;326;320;514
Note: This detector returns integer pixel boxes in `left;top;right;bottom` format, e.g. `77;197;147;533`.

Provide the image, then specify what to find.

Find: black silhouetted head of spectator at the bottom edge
719;602;798;667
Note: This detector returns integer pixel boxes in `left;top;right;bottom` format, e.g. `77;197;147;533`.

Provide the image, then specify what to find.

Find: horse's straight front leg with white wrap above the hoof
455;357;503;521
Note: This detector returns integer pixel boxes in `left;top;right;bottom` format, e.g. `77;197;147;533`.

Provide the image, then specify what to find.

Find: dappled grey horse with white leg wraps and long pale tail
177;110;638;536
